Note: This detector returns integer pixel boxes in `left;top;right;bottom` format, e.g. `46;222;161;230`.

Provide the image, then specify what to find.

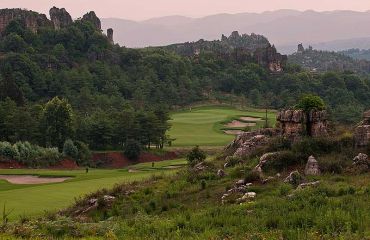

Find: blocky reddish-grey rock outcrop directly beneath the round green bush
277;110;328;139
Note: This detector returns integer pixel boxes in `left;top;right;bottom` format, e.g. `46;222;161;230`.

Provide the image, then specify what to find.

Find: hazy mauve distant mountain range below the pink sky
102;10;370;53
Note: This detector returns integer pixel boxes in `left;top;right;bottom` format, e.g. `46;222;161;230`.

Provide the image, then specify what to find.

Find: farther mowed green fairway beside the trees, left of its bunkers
169;106;276;147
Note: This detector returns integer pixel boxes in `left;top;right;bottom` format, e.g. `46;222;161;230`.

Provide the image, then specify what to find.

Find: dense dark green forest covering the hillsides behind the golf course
0;9;370;158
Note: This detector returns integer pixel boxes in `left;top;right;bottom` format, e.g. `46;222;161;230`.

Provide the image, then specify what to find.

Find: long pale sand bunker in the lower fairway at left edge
0;175;71;184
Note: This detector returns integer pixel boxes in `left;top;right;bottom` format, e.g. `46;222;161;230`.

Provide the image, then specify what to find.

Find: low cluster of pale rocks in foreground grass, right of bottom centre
221;179;257;204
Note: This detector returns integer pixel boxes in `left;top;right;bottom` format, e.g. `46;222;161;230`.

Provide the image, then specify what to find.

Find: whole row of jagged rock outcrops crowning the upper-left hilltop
0;7;113;43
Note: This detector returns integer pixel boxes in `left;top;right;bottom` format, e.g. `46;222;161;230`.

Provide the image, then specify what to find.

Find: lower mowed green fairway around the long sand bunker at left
0;159;186;220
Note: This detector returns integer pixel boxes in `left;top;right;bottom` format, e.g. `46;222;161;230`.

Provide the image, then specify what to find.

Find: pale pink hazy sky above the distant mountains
0;0;370;20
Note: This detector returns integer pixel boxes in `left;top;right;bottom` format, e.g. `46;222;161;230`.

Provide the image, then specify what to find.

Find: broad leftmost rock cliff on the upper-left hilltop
0;9;52;33
